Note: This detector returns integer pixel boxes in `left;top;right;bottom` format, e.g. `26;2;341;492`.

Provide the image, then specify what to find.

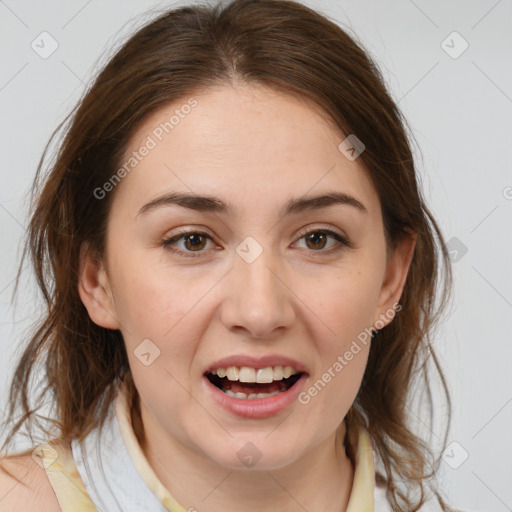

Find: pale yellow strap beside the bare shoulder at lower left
33;440;98;512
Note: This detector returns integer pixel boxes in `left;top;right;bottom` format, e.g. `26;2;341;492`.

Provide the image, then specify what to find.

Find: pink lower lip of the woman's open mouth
203;373;307;418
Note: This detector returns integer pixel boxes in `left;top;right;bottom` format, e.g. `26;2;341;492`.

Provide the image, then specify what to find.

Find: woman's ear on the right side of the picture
373;232;418;330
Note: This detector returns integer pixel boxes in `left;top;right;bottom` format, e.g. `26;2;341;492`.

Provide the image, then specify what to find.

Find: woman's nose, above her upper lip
221;245;295;339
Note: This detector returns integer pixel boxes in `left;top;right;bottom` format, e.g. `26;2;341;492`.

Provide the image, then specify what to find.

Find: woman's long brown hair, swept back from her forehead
4;0;452;511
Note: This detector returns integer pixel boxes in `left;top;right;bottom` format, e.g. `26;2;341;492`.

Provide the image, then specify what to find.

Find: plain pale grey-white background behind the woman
0;0;512;512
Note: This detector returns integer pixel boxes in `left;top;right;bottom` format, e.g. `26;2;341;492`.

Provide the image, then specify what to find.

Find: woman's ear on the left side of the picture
78;242;120;329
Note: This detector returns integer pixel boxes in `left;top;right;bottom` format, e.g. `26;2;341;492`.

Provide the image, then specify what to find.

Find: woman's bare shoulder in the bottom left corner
0;454;61;512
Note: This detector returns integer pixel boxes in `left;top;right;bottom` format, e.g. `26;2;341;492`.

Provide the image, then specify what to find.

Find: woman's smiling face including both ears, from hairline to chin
81;86;413;469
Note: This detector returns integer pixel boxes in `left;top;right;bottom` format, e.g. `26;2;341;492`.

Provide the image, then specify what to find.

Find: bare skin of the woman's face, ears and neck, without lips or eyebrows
80;84;415;512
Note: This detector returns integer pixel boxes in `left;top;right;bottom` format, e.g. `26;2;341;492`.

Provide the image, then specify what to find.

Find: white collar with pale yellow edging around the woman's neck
67;382;379;512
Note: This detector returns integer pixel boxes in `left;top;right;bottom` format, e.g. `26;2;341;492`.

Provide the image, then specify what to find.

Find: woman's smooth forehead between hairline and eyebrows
116;86;378;219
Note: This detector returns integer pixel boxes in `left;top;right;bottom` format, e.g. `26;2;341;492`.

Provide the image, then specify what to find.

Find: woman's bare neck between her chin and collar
132;404;354;512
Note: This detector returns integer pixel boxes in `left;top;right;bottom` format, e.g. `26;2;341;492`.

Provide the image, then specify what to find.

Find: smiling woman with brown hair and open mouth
0;0;451;512
